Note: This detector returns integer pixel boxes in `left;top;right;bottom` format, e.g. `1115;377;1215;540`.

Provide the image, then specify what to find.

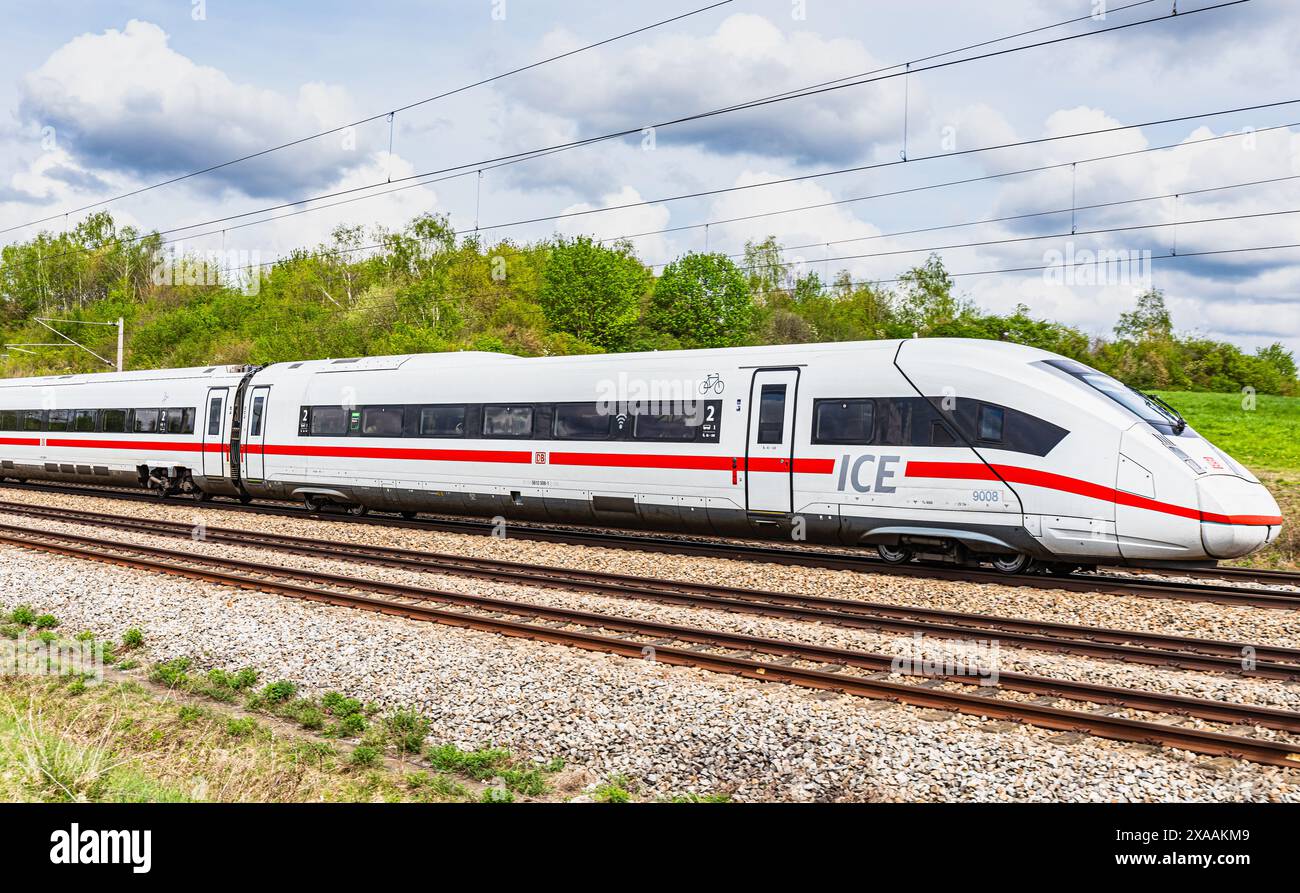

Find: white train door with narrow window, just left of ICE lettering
745;369;800;513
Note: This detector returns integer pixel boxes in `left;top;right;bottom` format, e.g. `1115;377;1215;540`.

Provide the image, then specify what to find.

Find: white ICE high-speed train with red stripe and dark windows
0;338;1282;573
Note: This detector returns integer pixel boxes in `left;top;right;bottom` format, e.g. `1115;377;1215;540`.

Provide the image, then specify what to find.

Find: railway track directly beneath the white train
4;482;1300;610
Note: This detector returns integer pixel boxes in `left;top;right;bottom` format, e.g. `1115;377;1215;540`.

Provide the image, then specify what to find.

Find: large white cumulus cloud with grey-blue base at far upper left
18;21;369;196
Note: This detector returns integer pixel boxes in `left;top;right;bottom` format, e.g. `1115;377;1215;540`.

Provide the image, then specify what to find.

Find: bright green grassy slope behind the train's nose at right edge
1158;391;1300;471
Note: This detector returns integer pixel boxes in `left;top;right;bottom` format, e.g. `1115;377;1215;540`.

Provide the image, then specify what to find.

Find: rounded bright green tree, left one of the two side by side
538;235;650;350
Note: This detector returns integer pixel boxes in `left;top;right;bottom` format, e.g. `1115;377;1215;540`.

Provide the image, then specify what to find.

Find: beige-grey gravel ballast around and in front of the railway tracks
0;506;1300;801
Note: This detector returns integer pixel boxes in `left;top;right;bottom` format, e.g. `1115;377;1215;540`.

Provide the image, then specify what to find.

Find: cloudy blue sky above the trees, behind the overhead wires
0;0;1300;351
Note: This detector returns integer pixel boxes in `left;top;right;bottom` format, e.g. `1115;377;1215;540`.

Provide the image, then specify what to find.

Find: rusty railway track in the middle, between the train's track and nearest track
0;502;1300;680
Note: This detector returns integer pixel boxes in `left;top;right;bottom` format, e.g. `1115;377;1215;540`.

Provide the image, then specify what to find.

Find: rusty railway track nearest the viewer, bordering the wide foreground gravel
0;525;1300;768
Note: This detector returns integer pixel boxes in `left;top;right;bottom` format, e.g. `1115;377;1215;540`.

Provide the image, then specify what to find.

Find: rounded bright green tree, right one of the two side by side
649;253;754;347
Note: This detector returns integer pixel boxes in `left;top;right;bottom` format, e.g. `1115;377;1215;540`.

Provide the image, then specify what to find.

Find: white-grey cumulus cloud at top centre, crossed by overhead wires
503;14;923;162
